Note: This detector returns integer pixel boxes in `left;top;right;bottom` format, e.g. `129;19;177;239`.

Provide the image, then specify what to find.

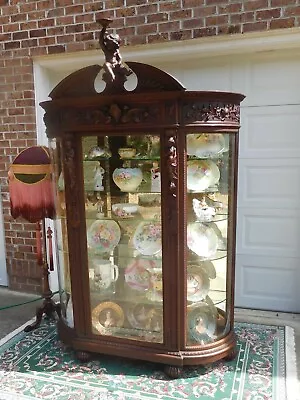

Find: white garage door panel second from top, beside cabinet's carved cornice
240;105;300;159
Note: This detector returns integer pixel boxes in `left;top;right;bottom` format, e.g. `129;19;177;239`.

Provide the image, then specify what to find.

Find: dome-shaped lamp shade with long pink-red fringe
8;146;55;222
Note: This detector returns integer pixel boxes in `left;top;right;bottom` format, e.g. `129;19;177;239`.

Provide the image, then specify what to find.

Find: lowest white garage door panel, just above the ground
235;256;300;312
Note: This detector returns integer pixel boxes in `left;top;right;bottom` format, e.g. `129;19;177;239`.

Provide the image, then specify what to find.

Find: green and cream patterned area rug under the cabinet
0;321;299;400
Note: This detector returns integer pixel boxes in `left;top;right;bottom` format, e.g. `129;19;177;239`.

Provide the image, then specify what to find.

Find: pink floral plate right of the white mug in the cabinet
125;258;153;291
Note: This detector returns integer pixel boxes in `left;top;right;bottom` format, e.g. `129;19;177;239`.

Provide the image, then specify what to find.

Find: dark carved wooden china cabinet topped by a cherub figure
41;21;244;377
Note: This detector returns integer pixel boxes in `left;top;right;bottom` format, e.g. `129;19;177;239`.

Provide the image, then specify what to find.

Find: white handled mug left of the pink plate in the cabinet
93;258;119;289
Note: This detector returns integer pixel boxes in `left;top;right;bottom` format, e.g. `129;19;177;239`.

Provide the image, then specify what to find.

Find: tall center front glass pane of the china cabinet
82;134;163;342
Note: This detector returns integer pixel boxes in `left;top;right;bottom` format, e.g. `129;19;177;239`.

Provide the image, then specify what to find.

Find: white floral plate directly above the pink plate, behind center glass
132;221;161;256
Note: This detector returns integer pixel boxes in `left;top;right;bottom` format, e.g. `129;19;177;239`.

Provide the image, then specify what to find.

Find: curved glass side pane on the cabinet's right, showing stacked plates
186;133;235;345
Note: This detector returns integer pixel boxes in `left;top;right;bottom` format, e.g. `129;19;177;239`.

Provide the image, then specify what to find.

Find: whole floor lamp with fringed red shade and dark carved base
8;146;61;332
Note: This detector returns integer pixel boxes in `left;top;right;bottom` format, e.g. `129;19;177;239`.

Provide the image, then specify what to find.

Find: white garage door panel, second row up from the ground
237;207;300;257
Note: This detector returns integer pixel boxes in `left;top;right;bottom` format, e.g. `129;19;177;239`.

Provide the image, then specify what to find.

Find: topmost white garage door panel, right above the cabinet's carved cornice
233;52;300;107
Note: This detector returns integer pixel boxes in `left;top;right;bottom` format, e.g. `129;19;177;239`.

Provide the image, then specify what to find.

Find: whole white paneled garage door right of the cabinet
159;51;300;312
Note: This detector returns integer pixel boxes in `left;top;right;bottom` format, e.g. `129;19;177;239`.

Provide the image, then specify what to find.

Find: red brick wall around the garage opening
0;0;300;292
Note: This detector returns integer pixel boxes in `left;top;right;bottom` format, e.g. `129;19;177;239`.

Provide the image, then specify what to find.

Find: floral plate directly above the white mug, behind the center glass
87;219;121;253
